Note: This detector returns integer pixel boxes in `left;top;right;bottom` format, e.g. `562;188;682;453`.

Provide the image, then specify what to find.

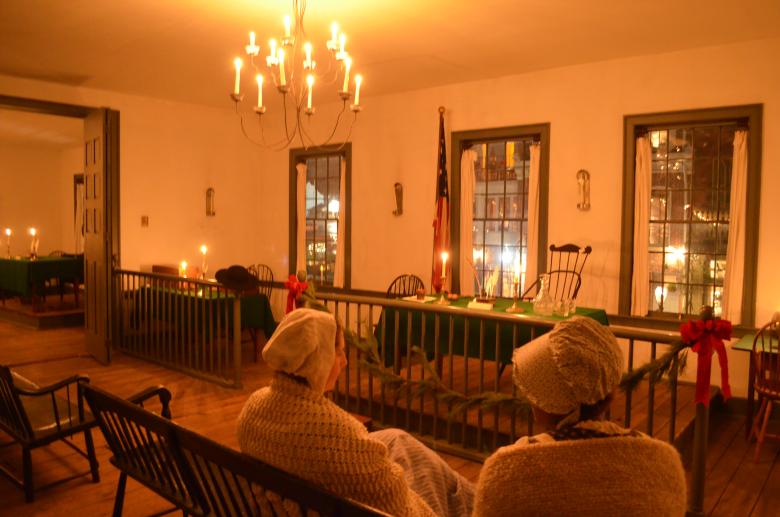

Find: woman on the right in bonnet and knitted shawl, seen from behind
474;317;686;517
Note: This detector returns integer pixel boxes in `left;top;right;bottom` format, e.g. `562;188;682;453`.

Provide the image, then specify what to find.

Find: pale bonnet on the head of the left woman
263;309;336;392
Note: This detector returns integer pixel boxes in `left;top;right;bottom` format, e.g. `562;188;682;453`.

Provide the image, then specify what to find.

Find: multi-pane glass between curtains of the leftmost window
306;153;344;285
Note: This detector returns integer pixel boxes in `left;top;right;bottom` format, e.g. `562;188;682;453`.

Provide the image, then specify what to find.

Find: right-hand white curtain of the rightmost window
721;130;748;325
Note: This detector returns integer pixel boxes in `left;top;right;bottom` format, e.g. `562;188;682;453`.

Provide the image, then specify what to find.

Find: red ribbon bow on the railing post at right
680;319;731;406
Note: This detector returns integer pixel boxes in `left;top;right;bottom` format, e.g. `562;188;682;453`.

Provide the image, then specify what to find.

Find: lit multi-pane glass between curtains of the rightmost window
648;124;736;314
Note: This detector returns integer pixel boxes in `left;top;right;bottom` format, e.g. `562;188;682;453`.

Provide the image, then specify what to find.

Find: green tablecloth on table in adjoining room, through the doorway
0;256;84;296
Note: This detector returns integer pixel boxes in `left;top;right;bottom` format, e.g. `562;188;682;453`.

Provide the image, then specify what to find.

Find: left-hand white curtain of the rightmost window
631;136;652;316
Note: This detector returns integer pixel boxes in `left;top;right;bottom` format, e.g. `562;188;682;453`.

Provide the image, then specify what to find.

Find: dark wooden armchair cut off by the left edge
0;365;100;503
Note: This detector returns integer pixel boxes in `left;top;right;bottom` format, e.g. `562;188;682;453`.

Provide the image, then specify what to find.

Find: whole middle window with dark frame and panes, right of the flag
451;125;549;296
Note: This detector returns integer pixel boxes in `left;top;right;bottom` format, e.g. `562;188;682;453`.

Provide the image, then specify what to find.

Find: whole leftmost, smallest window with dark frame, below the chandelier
290;144;351;287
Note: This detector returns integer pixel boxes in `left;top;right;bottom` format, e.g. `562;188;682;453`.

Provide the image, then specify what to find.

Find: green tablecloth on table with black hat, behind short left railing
133;287;277;338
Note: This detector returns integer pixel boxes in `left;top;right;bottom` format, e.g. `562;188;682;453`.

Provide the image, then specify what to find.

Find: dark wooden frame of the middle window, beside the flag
450;122;550;293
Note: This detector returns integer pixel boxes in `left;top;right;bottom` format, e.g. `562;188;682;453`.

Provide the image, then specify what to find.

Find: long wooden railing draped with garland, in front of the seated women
308;293;679;458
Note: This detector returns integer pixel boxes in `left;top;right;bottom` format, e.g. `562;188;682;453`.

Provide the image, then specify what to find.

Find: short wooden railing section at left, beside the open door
112;270;241;387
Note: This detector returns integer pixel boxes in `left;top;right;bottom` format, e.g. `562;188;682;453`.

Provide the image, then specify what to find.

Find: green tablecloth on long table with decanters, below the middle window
375;297;609;366
